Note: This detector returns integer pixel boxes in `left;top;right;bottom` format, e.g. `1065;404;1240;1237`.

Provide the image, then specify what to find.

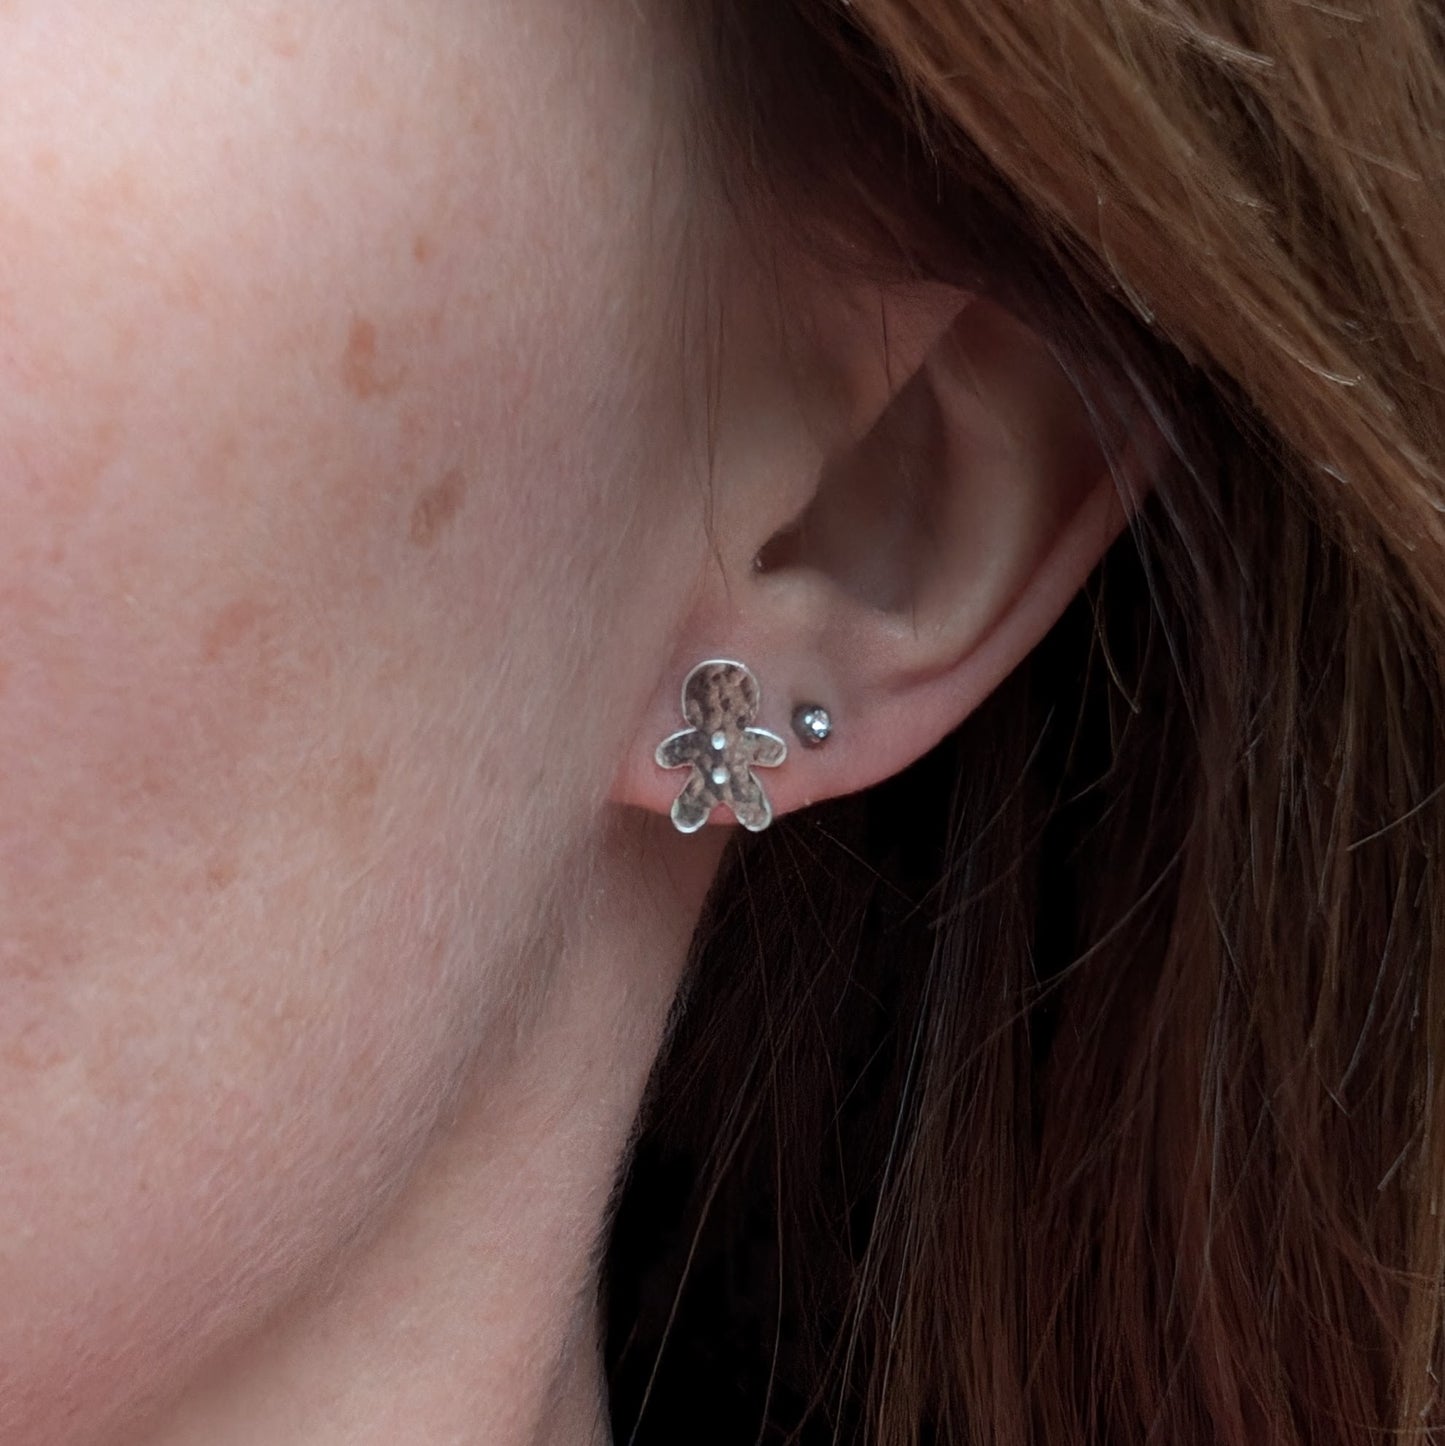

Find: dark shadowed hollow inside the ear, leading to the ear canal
754;366;949;613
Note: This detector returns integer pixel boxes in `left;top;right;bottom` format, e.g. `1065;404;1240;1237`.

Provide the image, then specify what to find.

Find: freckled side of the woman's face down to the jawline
0;0;711;1442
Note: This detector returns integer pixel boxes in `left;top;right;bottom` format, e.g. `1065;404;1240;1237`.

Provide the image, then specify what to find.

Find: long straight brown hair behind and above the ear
609;0;1445;1446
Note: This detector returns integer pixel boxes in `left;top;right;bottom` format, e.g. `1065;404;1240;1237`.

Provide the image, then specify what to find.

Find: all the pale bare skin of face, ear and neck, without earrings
0;0;1145;1446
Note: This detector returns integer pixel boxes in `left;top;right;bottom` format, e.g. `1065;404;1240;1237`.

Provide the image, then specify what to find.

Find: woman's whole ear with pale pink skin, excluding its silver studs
613;288;1161;823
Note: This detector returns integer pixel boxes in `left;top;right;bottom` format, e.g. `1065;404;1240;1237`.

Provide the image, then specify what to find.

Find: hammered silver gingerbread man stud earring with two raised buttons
657;658;788;833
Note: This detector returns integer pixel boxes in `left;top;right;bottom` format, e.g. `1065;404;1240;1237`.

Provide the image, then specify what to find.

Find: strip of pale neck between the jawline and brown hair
145;816;723;1446
